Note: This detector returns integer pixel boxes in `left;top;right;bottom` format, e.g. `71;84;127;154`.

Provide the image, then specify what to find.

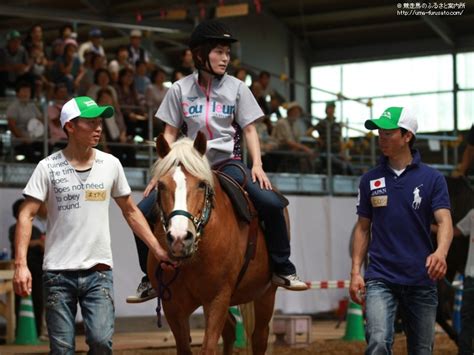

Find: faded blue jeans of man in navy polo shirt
365;280;438;355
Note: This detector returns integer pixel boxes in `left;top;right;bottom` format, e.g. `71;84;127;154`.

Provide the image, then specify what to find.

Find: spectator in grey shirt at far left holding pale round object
6;81;44;163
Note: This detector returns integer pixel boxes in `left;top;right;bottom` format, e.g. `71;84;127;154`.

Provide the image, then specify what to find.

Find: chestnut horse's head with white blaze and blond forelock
154;133;213;259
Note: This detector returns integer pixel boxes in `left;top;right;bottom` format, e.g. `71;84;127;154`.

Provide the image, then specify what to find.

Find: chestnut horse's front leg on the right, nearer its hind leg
201;290;231;355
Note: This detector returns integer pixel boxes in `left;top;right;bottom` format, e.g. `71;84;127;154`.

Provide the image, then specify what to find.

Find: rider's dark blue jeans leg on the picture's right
220;160;296;275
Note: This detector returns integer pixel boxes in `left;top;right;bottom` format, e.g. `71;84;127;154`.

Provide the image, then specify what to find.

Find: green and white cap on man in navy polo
364;107;418;135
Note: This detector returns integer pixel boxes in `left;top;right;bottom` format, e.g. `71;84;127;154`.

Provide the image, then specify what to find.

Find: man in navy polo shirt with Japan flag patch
349;107;453;354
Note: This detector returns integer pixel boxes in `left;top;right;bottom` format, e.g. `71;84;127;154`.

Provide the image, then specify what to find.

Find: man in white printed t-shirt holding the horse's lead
13;96;175;354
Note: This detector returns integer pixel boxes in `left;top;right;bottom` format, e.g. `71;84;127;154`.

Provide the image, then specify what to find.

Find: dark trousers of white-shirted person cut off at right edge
459;276;474;355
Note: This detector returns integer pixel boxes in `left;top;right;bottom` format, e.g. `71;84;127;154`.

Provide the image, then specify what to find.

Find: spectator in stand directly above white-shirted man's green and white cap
51;39;85;96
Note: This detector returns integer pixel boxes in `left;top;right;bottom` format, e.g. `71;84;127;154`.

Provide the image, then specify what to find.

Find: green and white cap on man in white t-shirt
60;96;114;128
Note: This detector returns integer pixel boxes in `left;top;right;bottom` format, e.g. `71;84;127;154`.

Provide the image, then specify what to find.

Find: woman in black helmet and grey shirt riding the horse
127;20;308;302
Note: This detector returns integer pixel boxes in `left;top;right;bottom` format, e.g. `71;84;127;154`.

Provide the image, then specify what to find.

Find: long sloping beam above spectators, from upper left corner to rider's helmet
0;5;193;34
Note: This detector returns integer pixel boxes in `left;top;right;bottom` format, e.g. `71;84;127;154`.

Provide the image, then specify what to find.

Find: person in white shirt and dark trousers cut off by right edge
454;208;474;355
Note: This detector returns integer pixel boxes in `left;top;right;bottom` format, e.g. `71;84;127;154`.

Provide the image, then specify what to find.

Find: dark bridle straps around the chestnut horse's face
156;183;214;252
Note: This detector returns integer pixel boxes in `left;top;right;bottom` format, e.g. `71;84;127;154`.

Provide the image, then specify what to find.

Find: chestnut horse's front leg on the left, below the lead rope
163;302;193;355
